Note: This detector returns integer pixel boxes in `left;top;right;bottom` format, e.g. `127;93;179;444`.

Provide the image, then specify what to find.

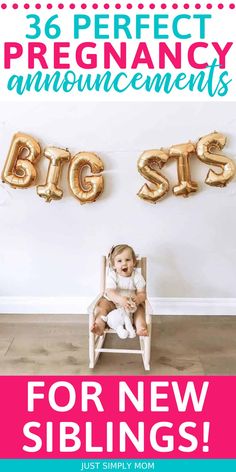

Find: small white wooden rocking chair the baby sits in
88;256;152;370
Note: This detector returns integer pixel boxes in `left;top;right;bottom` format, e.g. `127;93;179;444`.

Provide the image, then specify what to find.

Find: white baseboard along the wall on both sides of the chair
0;297;236;315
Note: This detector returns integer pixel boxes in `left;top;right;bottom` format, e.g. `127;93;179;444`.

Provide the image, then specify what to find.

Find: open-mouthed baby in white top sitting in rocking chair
91;244;148;336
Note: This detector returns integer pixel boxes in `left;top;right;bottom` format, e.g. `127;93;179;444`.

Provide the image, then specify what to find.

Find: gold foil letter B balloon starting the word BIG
2;133;41;188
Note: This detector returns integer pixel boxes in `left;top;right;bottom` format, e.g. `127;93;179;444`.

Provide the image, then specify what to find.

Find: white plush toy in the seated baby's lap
101;302;136;339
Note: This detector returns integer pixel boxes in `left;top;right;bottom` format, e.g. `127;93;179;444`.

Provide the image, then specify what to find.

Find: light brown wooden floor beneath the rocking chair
0;315;236;375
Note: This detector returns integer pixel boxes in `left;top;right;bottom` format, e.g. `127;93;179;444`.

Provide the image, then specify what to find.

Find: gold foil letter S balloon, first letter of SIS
137;149;169;203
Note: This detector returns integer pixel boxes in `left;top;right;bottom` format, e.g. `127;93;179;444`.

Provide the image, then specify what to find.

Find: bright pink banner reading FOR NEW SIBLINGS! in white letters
0;376;236;459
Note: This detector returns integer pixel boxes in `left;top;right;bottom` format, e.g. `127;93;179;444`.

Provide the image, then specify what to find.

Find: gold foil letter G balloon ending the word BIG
69;152;104;204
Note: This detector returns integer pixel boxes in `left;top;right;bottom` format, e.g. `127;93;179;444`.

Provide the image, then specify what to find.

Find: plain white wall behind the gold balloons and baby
0;102;236;312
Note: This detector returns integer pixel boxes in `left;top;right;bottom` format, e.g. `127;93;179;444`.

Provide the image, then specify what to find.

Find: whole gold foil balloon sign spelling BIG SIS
2;132;236;204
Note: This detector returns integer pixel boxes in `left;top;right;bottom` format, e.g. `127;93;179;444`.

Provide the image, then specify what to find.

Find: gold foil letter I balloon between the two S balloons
169;143;198;197
